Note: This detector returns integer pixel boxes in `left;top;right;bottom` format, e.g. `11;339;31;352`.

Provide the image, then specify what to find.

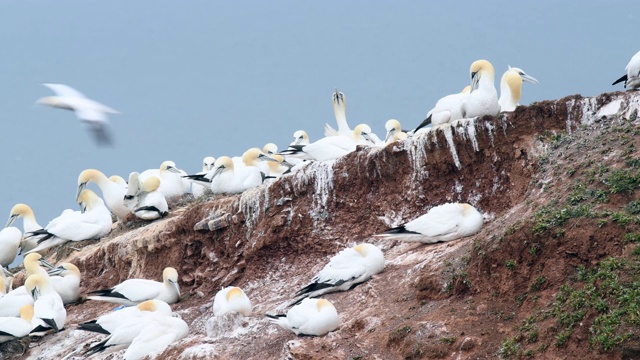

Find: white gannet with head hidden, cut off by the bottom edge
124;316;189;360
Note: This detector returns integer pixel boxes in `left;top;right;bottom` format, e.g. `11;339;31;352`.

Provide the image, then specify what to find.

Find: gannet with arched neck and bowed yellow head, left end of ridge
77;169;130;221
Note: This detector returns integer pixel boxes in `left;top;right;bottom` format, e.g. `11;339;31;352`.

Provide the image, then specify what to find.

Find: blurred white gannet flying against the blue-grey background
38;84;118;145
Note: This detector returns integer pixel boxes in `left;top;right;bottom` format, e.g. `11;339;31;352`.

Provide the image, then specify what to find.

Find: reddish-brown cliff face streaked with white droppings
7;93;640;359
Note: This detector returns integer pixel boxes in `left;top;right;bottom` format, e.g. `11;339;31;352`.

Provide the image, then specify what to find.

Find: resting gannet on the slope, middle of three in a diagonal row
293;243;384;304
